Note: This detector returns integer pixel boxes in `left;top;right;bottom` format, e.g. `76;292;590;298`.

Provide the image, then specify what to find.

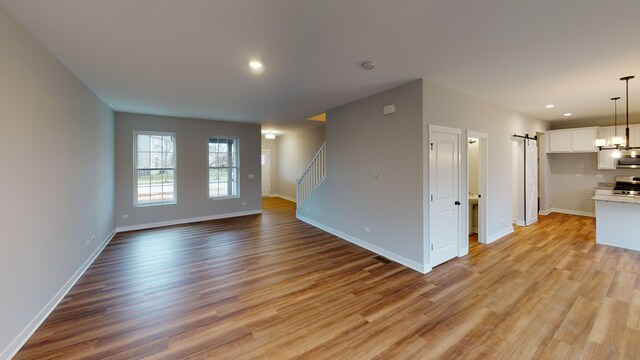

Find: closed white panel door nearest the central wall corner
429;127;460;266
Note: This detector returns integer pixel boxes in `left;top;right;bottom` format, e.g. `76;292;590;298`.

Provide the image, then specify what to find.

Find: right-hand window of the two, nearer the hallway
209;137;239;199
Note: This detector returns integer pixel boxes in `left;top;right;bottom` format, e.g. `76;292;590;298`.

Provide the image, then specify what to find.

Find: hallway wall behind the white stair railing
278;125;325;199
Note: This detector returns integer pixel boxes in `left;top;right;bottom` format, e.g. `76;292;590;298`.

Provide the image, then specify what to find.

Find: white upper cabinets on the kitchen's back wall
547;127;598;153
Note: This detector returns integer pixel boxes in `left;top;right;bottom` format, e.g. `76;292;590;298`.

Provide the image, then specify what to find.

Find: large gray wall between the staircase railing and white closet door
298;80;423;263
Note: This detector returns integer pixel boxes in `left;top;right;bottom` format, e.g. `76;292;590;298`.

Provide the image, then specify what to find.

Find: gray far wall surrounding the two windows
116;113;262;228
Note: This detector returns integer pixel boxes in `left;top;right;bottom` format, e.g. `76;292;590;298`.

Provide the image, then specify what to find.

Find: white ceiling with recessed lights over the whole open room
0;0;640;124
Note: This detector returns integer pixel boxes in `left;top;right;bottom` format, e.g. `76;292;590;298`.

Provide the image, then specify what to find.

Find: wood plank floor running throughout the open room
16;199;640;360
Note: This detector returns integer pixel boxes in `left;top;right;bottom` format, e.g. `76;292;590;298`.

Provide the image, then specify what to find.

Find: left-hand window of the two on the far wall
134;132;176;206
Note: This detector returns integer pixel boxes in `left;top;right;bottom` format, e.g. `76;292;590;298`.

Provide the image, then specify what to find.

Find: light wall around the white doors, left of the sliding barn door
423;80;547;248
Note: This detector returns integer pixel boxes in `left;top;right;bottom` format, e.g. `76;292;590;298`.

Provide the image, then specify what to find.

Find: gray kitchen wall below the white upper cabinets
546;153;640;214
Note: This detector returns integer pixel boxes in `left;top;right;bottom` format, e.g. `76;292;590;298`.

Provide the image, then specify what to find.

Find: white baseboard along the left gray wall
0;230;116;359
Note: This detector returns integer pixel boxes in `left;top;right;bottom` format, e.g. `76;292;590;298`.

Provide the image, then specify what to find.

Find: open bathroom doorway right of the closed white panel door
466;130;489;246
